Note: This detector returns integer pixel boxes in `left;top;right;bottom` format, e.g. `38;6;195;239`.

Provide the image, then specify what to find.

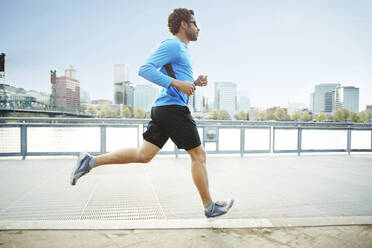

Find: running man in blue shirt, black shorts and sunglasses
71;8;234;218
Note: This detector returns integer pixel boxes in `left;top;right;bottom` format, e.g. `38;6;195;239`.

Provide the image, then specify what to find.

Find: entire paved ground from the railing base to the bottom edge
0;154;372;247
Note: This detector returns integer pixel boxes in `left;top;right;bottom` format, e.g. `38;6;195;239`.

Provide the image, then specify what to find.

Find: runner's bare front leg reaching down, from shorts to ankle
187;145;212;205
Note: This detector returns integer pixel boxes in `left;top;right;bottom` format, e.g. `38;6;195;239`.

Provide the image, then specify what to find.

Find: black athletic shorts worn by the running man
143;105;201;151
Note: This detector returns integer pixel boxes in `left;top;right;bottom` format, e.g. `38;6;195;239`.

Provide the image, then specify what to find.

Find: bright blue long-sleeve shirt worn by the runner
138;36;194;107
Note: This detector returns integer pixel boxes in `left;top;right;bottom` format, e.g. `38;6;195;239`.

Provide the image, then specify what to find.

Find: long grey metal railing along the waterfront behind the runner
0;118;372;159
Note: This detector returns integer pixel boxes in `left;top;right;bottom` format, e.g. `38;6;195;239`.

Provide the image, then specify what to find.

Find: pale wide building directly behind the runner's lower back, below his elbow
133;84;159;112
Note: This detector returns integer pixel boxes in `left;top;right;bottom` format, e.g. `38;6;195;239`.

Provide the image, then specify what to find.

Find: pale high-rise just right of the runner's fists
214;82;237;117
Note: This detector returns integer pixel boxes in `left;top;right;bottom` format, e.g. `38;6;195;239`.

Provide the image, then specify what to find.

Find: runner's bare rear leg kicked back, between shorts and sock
96;140;160;166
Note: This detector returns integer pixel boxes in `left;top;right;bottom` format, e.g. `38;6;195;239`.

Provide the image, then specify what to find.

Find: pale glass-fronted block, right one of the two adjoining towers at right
334;86;359;113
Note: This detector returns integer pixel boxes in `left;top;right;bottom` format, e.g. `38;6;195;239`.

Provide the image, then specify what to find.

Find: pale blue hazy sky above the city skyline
0;0;372;110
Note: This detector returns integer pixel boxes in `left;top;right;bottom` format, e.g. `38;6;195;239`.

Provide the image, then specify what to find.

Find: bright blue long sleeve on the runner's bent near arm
138;40;179;88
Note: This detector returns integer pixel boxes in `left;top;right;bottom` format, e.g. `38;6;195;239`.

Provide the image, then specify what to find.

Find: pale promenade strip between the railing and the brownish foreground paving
0;155;372;228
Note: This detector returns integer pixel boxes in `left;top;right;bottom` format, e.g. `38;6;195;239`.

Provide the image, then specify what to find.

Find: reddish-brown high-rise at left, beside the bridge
50;67;80;111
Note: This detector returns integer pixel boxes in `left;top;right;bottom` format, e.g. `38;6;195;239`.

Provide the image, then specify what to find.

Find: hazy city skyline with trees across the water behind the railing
0;54;372;122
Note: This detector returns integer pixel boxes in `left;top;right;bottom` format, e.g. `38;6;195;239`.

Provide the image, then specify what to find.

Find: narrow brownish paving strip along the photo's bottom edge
0;226;372;248
